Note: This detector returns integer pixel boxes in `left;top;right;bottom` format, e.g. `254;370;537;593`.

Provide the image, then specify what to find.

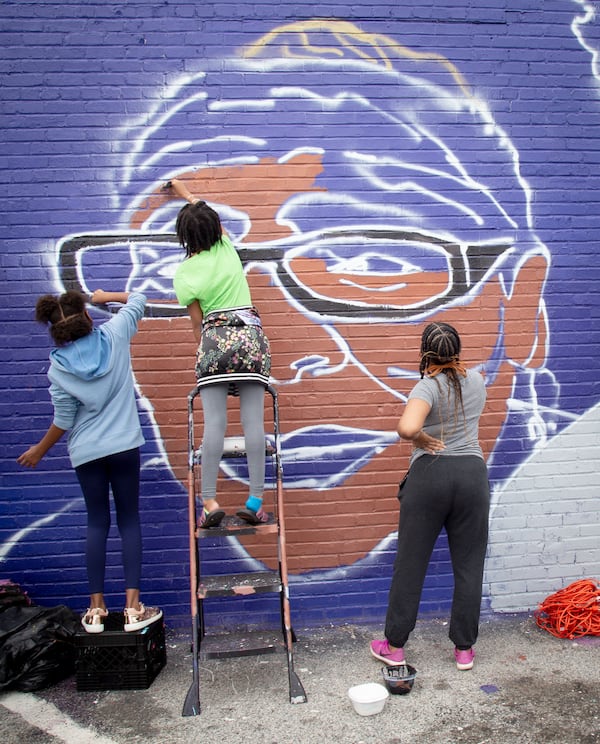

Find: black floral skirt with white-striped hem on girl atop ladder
196;307;271;395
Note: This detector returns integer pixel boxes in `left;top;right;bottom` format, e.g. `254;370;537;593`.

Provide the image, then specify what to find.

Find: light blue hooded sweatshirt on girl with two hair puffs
48;292;146;468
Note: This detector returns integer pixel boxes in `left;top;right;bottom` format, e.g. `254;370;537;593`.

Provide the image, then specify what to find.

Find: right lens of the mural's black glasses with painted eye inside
270;228;512;321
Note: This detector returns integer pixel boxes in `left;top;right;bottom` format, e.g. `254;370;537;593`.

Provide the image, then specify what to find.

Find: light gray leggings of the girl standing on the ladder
200;382;265;501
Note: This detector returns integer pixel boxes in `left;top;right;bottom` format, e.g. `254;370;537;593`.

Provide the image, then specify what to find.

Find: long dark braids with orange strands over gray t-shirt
419;323;464;425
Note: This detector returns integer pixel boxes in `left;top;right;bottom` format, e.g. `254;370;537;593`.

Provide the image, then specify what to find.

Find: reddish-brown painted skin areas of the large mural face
131;155;547;573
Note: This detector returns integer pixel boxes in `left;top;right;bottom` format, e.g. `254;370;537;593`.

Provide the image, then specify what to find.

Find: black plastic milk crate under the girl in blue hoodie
75;612;167;692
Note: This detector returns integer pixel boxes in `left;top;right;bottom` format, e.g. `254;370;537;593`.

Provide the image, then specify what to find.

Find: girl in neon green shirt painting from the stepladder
166;179;271;528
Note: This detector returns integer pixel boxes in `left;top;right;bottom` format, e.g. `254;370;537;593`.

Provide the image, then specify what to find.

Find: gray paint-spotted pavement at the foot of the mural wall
0;615;600;744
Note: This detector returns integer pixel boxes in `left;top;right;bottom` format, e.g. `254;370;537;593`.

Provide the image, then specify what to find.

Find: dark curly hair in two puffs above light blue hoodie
35;290;94;346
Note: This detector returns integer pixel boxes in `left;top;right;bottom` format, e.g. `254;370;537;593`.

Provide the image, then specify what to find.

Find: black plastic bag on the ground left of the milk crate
0;605;79;692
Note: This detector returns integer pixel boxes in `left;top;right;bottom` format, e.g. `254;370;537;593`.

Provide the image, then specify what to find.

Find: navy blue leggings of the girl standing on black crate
75;448;142;594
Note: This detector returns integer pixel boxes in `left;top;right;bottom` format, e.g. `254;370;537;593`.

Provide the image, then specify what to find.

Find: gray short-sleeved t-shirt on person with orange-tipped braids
408;369;486;463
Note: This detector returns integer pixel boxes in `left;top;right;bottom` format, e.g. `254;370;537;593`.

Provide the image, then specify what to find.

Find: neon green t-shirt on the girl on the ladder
173;235;252;316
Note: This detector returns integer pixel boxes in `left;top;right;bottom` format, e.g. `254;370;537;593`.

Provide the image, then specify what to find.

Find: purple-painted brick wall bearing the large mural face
0;0;600;624
